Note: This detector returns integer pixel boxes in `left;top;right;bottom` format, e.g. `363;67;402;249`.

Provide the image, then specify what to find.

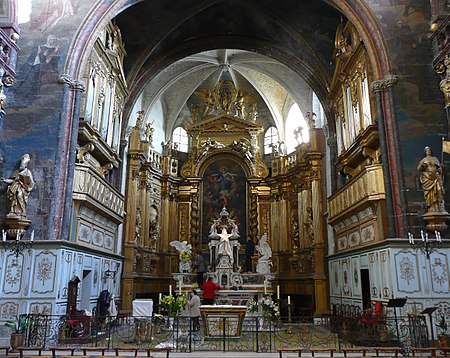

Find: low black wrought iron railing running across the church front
19;315;429;352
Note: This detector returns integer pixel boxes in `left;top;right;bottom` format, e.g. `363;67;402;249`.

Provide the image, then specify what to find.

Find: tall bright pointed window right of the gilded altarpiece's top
285;103;309;153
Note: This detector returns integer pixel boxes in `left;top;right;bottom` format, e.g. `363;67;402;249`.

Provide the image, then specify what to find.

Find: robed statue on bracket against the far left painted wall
1;154;35;217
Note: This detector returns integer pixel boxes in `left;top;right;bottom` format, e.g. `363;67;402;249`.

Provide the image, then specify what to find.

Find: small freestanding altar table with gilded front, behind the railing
200;305;247;339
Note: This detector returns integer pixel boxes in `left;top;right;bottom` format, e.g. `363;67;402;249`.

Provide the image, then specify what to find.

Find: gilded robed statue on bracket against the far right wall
417;146;446;213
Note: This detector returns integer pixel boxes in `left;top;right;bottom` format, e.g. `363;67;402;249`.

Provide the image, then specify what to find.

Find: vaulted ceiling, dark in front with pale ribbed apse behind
116;0;341;138
